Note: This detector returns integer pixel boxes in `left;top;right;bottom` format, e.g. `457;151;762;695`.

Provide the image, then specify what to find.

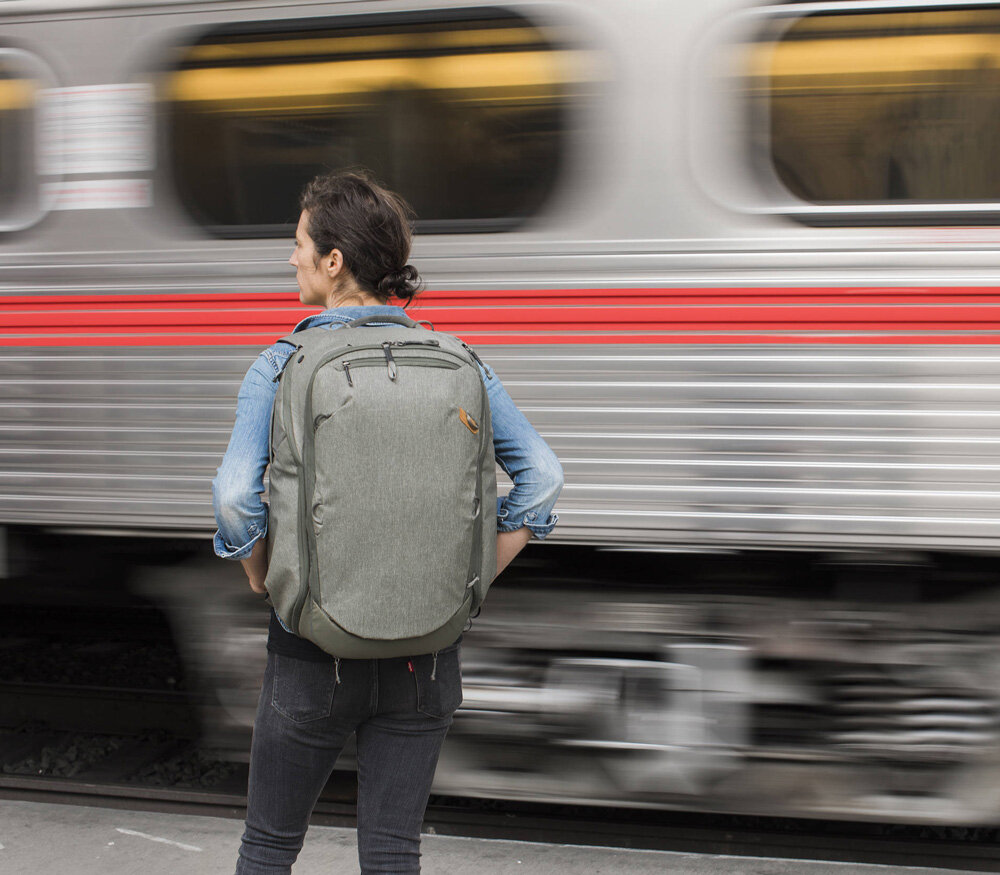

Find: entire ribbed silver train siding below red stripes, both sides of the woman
0;344;1000;549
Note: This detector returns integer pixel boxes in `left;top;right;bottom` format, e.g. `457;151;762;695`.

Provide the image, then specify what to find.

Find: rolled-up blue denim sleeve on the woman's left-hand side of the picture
212;347;291;559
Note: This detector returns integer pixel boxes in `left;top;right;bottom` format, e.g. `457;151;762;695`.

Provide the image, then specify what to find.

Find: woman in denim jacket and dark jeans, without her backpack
212;173;562;875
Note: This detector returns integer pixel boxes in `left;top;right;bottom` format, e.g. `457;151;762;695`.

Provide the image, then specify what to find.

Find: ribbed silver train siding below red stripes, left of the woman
0;348;238;532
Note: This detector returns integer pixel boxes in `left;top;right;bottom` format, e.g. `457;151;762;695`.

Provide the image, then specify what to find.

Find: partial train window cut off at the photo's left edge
0;48;48;231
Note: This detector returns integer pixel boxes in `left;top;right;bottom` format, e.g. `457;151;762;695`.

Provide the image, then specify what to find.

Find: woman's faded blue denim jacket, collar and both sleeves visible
212;306;563;559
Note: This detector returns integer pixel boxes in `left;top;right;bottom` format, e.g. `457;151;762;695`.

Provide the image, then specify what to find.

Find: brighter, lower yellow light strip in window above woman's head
167;44;592;103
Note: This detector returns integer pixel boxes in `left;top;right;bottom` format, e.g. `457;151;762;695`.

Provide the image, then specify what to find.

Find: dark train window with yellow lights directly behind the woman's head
162;9;588;237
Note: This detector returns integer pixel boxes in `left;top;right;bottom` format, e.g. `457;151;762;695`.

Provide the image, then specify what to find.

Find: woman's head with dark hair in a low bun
289;171;420;307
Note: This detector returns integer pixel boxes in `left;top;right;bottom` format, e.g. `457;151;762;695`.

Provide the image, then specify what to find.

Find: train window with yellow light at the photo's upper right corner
749;3;1000;222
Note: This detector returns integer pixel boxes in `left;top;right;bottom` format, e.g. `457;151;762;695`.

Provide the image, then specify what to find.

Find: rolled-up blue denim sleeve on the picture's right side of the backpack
483;365;563;540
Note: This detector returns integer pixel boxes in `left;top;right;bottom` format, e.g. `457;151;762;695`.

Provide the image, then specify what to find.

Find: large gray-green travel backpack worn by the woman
265;315;497;659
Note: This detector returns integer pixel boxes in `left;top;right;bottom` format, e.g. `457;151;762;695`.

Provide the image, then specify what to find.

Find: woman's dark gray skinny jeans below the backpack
236;642;462;875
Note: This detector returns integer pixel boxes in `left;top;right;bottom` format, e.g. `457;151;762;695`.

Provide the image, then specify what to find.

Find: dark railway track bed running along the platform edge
0;731;1000;872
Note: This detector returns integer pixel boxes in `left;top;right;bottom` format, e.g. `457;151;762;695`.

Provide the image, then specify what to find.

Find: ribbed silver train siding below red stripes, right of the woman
493;346;1000;548
